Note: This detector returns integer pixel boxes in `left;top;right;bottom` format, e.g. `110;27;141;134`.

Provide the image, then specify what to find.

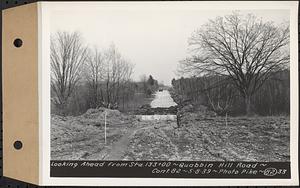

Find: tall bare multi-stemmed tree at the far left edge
50;32;87;114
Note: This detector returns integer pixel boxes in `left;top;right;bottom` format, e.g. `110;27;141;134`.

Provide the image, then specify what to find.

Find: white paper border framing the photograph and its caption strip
38;1;299;186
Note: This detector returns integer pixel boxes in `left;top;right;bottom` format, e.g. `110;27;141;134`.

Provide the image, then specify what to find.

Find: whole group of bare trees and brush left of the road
51;32;158;115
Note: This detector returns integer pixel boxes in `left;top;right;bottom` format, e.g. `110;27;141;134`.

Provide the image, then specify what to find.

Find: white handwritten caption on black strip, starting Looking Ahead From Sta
51;161;289;177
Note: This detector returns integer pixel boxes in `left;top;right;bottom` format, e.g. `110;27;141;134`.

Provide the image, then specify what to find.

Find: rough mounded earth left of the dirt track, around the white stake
51;108;136;160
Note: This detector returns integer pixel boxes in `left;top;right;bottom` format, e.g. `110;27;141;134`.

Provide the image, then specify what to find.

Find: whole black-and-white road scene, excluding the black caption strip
50;4;290;162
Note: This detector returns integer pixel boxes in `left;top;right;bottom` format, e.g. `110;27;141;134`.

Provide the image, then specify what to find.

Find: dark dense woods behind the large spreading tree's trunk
172;70;290;116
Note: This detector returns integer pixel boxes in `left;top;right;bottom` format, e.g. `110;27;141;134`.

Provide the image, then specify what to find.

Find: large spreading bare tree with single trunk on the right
180;12;289;115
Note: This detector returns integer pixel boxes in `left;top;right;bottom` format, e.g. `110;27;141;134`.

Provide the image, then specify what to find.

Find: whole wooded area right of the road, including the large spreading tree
177;12;290;115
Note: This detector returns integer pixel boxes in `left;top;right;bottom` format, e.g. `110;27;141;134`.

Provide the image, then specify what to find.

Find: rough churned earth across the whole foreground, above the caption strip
51;104;290;161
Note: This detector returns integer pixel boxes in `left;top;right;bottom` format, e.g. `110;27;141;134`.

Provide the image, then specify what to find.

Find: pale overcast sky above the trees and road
51;6;289;85
